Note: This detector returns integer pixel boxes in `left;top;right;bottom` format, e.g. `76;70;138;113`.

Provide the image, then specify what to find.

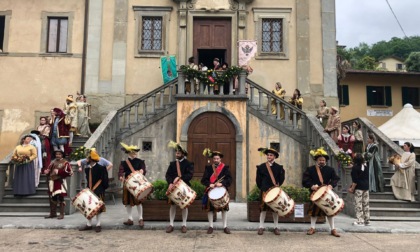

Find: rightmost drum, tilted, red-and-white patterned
311;186;344;216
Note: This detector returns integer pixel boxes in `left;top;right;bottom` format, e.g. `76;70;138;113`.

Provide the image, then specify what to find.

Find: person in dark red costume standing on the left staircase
50;108;69;152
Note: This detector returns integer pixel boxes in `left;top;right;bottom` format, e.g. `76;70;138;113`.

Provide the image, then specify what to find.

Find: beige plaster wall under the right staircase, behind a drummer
246;114;306;190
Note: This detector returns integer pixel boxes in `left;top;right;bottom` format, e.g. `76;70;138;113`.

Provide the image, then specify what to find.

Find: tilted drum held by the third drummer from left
166;179;197;209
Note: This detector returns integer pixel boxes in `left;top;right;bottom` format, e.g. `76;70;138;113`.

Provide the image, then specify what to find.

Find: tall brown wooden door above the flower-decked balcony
193;18;232;66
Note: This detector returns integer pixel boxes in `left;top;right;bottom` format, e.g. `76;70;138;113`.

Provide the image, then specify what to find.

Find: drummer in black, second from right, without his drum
256;148;285;235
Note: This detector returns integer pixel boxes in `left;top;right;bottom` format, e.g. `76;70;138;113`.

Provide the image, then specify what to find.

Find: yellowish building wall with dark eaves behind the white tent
340;74;420;127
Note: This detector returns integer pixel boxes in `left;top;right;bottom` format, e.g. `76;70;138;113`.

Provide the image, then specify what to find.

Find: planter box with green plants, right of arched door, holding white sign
247;186;325;223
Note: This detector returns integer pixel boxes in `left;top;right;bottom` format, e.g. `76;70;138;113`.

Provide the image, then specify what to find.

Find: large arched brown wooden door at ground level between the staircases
187;112;236;199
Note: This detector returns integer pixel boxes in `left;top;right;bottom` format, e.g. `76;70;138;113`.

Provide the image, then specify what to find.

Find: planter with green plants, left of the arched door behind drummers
143;179;213;221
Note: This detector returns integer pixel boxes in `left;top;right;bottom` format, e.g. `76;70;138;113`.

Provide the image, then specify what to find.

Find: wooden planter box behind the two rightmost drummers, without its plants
247;201;325;223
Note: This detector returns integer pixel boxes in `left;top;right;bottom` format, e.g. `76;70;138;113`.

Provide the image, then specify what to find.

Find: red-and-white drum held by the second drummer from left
125;171;153;201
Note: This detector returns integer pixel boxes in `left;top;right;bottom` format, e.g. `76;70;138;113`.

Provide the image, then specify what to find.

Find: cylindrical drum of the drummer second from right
263;187;295;217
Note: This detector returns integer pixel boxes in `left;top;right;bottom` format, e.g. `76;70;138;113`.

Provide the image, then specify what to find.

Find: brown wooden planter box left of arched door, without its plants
143;200;217;221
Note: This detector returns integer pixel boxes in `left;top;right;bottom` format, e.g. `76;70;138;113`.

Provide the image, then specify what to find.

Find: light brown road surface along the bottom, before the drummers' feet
0;229;420;252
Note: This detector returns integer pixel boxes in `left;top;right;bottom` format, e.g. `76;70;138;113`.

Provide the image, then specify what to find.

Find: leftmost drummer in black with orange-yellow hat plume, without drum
79;150;108;233
